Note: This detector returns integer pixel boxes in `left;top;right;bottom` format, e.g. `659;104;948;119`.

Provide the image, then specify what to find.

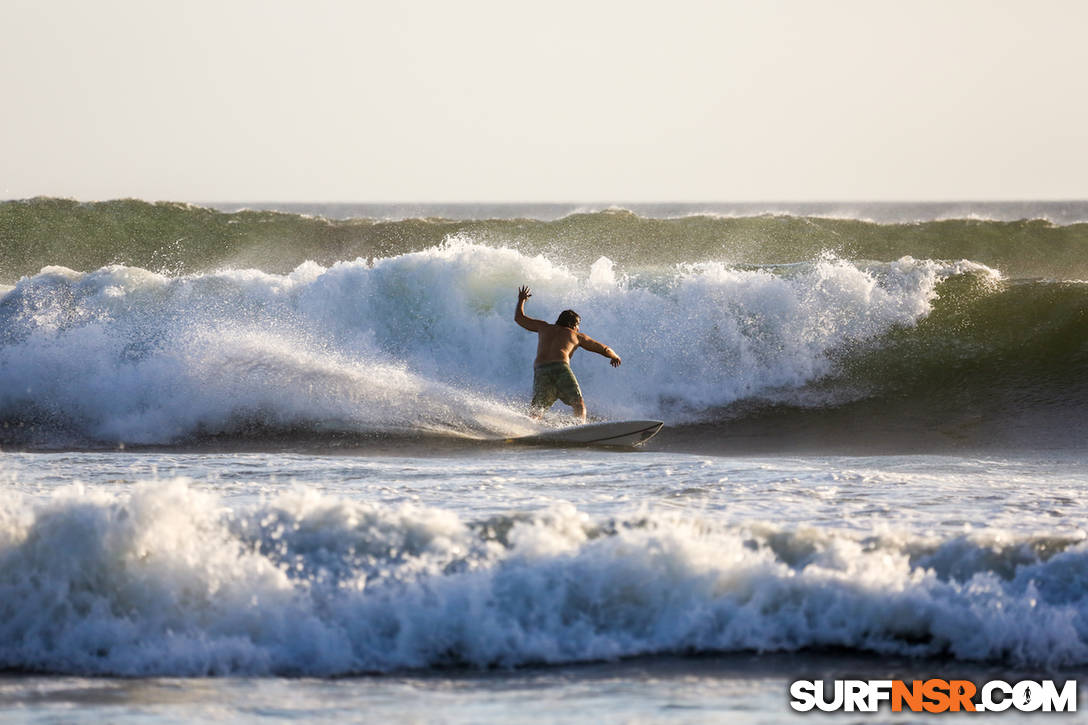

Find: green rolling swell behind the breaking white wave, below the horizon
0;198;1088;284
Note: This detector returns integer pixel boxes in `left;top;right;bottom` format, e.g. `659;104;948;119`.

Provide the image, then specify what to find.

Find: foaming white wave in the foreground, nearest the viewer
0;481;1088;676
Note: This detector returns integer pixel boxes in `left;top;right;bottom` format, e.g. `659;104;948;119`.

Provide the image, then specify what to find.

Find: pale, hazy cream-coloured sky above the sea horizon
0;0;1088;201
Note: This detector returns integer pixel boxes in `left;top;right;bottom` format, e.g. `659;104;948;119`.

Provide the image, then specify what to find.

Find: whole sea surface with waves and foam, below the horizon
0;198;1088;723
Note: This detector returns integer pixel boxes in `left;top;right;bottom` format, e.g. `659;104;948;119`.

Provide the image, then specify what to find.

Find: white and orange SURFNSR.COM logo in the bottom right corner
790;679;1077;712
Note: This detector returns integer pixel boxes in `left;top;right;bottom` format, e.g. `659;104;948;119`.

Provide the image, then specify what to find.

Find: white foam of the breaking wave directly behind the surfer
0;238;997;443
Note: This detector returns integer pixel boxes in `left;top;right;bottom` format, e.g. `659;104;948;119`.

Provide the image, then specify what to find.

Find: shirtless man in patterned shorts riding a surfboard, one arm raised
514;286;620;422
